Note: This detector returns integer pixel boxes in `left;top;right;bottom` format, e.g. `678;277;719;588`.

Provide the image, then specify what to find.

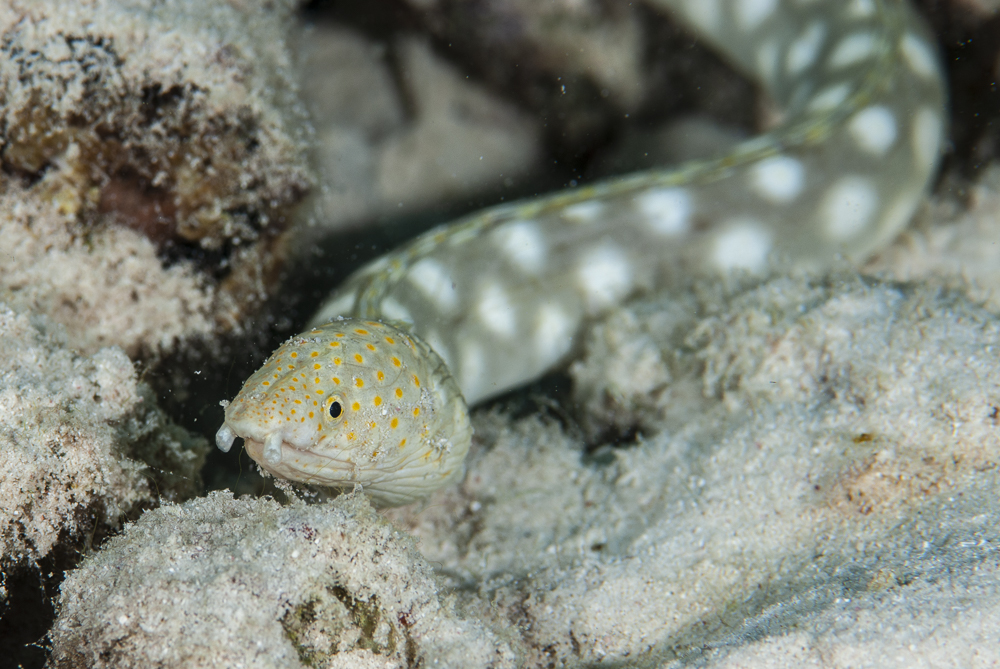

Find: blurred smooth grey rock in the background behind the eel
297;21;542;238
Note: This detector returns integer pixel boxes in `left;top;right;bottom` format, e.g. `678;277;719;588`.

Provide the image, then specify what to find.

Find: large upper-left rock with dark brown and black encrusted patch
0;0;311;356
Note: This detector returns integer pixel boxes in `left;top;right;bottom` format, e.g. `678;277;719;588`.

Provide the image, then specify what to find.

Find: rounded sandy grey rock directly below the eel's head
49;492;514;669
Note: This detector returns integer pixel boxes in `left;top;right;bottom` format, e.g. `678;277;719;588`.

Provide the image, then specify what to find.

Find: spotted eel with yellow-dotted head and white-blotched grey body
217;0;945;505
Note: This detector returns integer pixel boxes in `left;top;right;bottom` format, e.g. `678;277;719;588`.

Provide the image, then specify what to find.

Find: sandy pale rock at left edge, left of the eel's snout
0;303;209;576
